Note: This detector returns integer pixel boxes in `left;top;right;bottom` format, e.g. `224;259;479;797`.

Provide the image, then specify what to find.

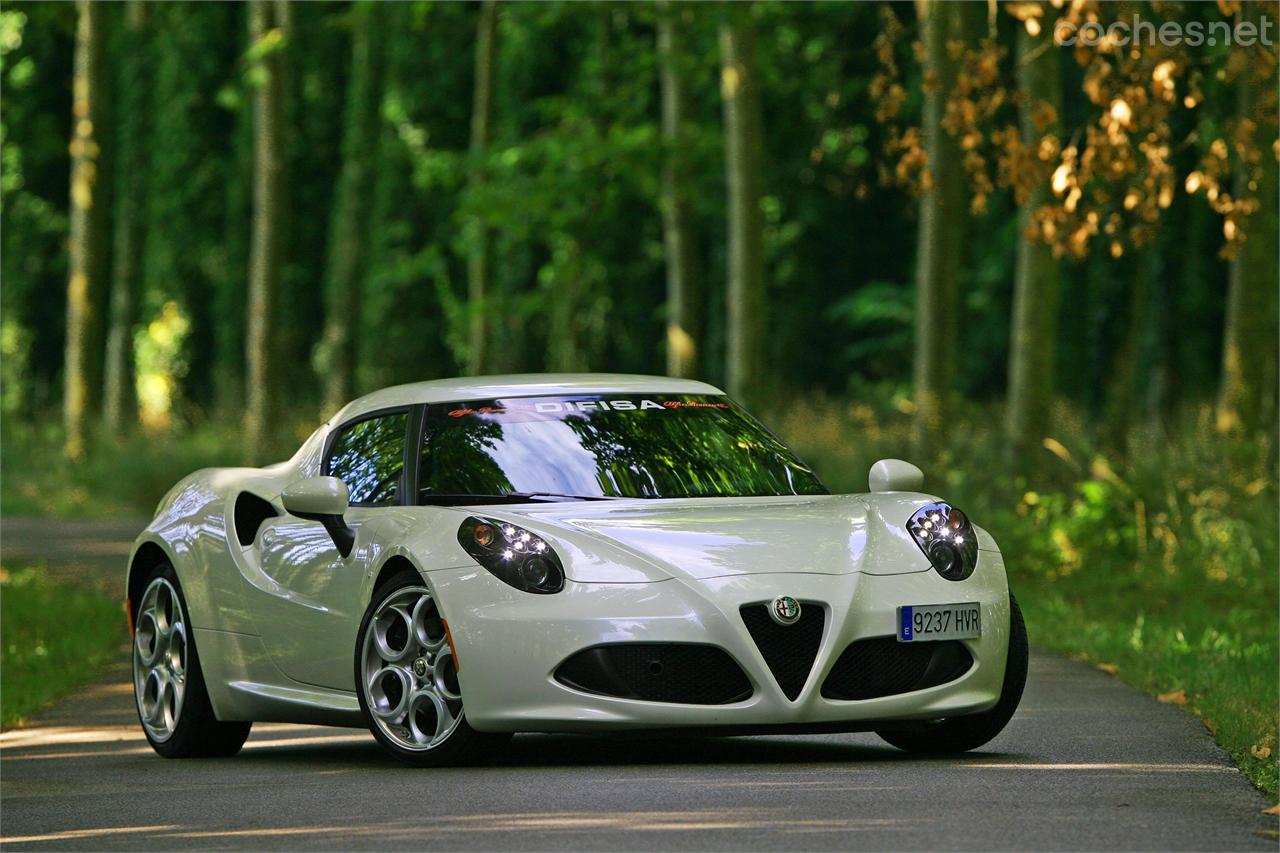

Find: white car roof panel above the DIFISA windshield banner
329;373;724;424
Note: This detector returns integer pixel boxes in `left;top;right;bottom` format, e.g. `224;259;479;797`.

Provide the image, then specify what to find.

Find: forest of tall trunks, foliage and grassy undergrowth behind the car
0;0;1280;797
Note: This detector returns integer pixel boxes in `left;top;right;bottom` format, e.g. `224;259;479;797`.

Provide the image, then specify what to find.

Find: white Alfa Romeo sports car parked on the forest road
127;374;1028;765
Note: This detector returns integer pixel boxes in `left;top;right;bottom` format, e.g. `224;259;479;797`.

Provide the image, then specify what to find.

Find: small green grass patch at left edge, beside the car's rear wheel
0;566;128;727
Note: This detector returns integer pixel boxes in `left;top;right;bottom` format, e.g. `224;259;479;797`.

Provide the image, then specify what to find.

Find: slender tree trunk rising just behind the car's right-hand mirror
914;0;983;455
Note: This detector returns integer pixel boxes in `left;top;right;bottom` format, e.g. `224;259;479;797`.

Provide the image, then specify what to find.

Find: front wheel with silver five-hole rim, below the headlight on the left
356;569;511;767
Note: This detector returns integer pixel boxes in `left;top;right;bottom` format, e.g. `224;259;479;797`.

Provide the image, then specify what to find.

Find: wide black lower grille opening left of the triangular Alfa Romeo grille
556;643;751;704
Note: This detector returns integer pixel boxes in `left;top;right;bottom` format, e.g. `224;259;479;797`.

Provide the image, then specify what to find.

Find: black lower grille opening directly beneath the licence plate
822;637;973;699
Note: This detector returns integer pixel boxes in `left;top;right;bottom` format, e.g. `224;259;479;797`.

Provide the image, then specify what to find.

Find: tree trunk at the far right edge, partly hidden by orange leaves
1217;3;1280;439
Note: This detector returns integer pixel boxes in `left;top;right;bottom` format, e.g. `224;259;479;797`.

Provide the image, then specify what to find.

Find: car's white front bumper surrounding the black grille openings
428;551;1009;731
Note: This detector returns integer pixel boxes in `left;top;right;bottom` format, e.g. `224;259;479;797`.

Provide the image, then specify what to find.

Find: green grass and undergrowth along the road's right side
772;391;1280;800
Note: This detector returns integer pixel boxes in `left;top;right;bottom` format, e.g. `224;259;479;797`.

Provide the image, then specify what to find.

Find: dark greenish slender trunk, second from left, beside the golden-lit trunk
102;0;151;435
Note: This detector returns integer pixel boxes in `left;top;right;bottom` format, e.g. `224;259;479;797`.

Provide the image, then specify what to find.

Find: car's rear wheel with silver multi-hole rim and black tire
131;562;253;758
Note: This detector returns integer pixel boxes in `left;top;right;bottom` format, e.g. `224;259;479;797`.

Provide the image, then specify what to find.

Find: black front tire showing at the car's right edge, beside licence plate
876;593;1030;753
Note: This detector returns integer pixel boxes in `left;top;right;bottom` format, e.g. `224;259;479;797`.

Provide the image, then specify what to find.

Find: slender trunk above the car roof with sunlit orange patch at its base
658;0;703;377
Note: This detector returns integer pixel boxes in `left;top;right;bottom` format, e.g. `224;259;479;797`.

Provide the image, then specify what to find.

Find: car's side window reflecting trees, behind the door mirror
326;412;408;506
